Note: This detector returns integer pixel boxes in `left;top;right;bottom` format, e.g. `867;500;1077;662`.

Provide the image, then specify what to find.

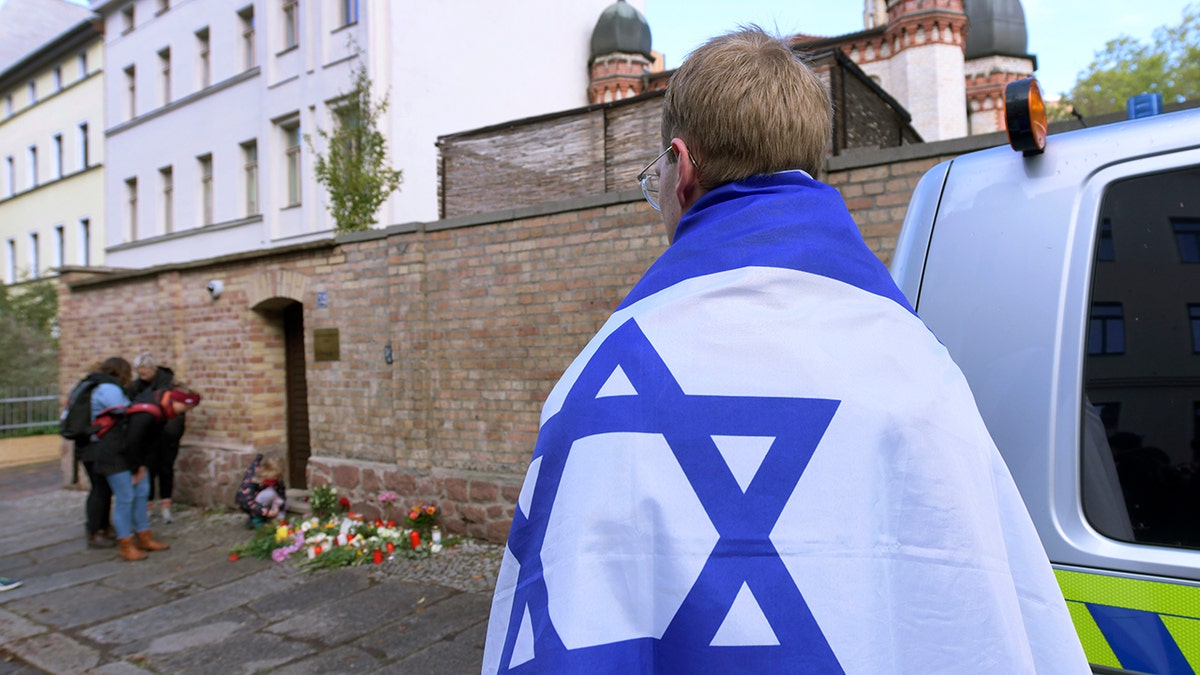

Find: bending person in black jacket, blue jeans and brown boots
88;384;200;561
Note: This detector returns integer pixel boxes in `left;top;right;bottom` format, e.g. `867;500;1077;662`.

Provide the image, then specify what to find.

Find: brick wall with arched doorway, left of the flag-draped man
60;191;665;540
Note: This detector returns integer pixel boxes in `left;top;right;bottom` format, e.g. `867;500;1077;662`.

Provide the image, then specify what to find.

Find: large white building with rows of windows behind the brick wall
92;0;641;268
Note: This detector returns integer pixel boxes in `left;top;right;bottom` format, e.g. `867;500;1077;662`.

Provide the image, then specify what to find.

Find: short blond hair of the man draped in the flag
662;25;833;184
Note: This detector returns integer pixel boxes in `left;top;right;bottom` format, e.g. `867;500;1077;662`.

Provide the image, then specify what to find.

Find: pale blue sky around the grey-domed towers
643;0;1200;96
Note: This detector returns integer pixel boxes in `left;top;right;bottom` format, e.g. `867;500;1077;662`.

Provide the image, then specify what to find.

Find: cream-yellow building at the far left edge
0;11;104;285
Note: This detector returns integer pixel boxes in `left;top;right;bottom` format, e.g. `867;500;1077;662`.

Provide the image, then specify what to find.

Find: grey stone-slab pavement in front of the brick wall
0;464;503;675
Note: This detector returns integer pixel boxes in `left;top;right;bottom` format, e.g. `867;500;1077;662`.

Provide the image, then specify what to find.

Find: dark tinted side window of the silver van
1080;167;1200;548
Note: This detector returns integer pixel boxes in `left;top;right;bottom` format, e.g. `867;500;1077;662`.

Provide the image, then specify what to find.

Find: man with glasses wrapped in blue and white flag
484;28;1088;675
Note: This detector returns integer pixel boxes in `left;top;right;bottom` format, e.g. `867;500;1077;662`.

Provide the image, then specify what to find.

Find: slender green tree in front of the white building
305;60;402;232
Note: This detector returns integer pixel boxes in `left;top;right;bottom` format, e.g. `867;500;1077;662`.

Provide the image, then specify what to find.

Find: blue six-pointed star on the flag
500;319;842;673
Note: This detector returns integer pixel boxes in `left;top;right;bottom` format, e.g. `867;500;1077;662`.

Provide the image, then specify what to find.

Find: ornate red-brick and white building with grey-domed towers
589;0;1037;141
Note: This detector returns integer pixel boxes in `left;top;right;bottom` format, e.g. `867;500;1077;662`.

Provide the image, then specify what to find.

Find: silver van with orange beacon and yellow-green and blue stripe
892;79;1200;674
